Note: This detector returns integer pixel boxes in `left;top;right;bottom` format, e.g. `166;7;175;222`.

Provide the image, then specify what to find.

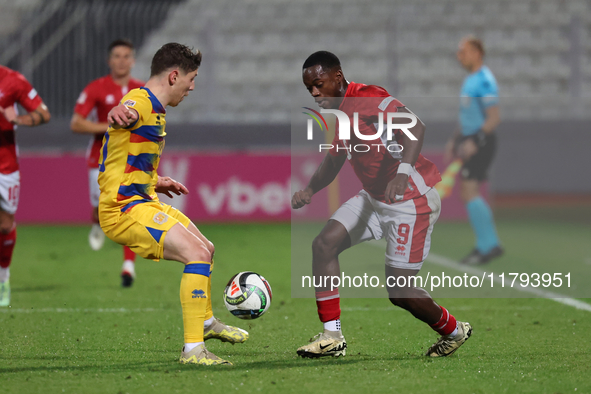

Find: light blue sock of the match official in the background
466;197;499;254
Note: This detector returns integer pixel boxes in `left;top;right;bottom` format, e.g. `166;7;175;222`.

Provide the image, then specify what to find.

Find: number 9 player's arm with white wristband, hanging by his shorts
384;107;425;204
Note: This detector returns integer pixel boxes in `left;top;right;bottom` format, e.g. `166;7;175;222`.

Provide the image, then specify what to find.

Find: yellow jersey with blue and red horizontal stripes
98;87;166;226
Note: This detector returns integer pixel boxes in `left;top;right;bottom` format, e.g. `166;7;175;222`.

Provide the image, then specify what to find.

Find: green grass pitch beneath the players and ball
0;215;591;393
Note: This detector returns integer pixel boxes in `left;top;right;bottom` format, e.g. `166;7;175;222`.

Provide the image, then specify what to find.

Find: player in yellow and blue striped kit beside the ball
98;43;248;365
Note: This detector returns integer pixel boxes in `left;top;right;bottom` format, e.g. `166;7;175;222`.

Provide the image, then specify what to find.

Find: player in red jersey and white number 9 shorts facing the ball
292;51;472;357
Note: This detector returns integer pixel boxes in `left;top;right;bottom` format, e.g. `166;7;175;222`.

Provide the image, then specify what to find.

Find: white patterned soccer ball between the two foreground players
224;272;273;320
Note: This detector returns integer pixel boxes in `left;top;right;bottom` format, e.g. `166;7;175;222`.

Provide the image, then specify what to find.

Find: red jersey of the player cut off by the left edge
0;66;43;174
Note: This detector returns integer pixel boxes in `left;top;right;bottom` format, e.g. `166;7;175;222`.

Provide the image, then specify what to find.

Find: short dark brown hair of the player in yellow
150;42;201;77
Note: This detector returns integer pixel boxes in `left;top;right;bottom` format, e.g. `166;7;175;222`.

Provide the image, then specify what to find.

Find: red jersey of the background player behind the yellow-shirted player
74;75;144;168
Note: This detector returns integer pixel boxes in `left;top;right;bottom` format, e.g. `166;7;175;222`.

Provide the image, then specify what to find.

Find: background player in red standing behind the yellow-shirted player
70;40;144;287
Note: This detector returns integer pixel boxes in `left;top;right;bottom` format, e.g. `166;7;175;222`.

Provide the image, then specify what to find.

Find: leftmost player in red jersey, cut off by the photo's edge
0;66;51;306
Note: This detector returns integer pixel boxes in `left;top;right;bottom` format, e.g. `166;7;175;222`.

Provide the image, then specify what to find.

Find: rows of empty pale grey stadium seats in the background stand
130;0;591;121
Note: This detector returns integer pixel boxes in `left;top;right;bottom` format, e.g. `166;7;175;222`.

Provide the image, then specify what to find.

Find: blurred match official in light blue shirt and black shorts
445;36;503;264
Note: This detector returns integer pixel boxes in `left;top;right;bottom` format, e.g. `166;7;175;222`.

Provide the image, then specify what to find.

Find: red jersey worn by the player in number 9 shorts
330;82;441;202
